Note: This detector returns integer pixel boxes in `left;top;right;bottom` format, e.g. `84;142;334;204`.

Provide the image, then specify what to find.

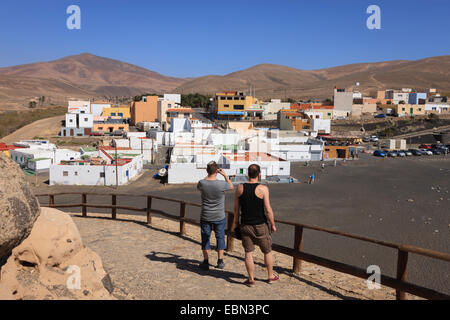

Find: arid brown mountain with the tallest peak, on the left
0;53;186;107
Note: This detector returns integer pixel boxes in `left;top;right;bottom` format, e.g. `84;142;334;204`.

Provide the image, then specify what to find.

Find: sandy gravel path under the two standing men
72;214;417;300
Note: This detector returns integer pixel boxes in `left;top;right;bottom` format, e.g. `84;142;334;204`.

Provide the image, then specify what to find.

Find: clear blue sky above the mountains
0;0;450;77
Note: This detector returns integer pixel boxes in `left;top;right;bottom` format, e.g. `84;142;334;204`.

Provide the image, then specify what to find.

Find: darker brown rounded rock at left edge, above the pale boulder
0;152;39;266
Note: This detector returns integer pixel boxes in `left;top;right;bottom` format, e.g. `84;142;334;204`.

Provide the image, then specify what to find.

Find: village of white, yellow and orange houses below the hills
0;84;450;186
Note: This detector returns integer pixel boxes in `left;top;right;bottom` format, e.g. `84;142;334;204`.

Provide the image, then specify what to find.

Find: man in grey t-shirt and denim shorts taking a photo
197;161;234;270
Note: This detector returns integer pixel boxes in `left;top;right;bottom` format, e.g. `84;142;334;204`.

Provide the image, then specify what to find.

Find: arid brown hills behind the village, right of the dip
176;56;450;99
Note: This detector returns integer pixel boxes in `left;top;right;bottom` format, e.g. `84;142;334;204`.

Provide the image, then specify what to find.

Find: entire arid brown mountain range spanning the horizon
0;53;450;111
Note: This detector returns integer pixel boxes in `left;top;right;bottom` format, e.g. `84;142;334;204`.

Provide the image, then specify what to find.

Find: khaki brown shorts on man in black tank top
241;223;272;253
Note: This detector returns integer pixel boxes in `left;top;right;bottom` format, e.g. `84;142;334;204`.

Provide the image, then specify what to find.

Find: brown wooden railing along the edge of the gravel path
36;192;450;300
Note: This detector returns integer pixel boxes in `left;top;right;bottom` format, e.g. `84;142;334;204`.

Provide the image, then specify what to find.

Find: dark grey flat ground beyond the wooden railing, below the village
31;154;450;294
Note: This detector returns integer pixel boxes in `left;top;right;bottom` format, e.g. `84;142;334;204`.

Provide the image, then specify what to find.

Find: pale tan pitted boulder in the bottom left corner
0;208;113;300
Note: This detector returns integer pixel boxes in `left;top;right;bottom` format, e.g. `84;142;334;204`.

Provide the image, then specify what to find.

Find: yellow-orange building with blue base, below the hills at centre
214;91;259;119
